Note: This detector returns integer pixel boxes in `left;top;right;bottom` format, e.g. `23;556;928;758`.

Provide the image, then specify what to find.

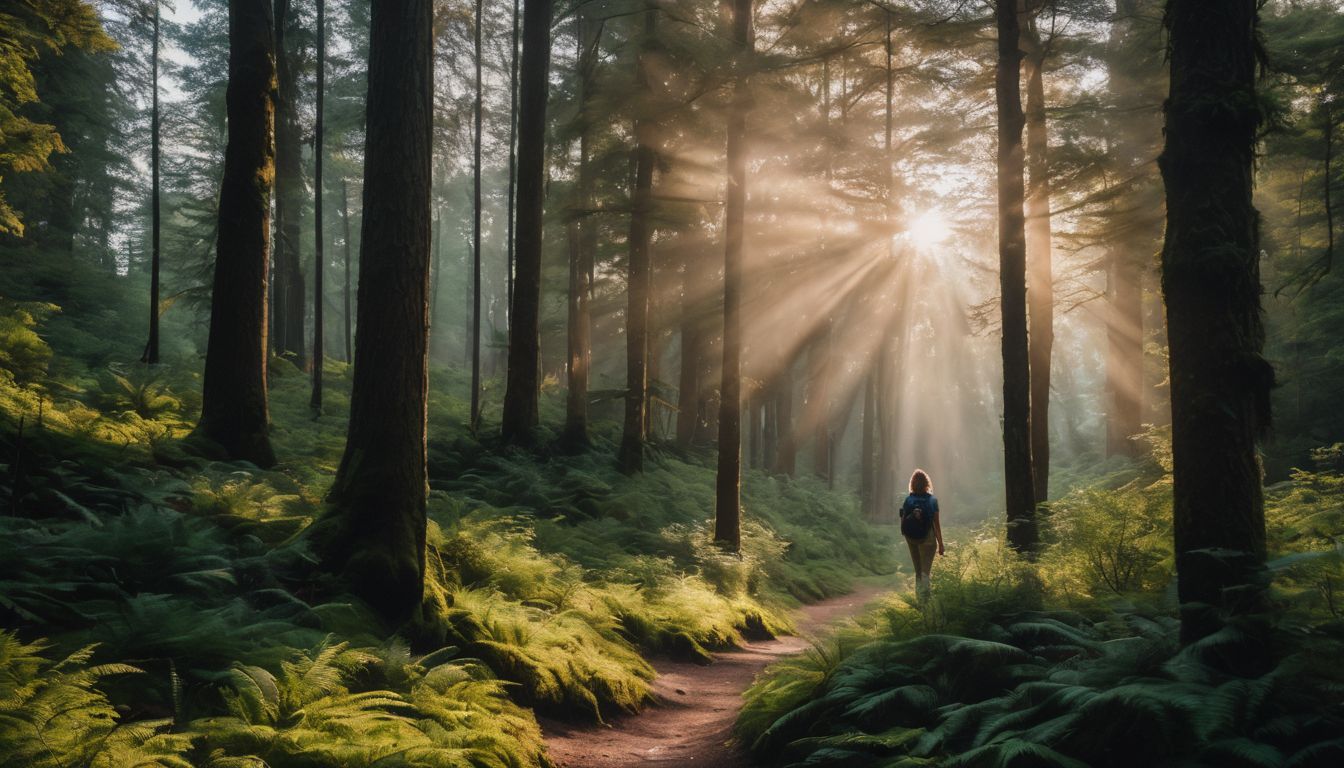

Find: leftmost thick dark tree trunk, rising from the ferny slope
195;0;276;467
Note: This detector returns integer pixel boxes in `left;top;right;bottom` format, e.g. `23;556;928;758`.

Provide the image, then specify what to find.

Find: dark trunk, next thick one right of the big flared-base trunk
501;0;551;447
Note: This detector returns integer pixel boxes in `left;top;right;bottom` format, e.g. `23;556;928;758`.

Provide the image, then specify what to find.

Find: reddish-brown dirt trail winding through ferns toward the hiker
542;586;892;768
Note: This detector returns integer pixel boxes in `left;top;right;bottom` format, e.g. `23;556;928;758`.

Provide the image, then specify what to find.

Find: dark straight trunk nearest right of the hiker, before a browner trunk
995;0;1038;554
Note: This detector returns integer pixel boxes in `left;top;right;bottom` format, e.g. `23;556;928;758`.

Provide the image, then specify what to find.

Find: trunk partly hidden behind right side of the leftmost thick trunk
274;0;308;369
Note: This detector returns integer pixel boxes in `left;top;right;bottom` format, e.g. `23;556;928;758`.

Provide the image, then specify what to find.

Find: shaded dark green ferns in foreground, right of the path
738;597;1344;767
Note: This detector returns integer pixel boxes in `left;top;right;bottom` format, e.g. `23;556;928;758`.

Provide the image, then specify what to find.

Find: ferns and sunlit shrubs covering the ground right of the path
735;445;1344;768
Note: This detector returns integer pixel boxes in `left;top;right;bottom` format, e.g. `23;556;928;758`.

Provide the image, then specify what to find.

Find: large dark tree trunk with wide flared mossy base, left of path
313;0;434;620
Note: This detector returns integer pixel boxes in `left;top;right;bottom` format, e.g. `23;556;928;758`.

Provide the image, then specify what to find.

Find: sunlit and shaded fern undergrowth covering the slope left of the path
0;301;894;768
